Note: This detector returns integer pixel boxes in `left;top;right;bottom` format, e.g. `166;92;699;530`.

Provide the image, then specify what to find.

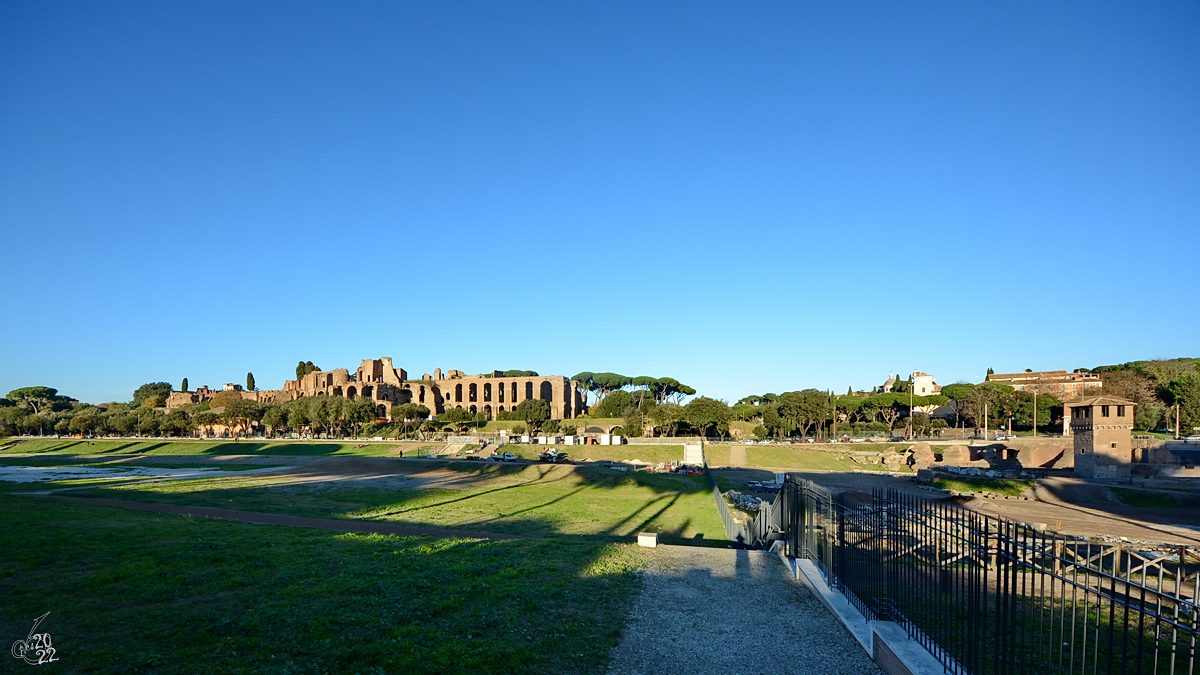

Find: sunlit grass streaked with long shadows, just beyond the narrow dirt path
71;461;726;546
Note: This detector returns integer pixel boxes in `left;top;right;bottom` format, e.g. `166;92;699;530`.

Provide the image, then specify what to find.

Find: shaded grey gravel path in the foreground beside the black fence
610;546;881;675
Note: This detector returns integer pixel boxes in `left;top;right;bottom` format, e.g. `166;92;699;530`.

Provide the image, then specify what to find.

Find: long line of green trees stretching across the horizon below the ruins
0;359;1200;437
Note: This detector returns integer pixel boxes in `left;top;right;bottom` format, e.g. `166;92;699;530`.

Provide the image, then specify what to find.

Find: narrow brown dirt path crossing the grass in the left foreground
47;495;527;539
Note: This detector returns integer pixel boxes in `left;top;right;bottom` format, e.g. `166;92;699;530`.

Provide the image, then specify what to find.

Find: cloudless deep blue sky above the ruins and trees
0;1;1200;402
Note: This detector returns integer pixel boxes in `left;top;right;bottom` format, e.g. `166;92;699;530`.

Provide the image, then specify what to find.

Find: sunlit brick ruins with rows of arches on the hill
167;357;587;419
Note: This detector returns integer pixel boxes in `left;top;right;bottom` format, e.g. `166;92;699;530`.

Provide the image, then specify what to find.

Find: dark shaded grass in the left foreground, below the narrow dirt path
0;494;642;674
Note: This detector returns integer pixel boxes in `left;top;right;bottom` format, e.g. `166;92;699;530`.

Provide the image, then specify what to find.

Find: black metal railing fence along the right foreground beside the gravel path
772;477;1200;675
